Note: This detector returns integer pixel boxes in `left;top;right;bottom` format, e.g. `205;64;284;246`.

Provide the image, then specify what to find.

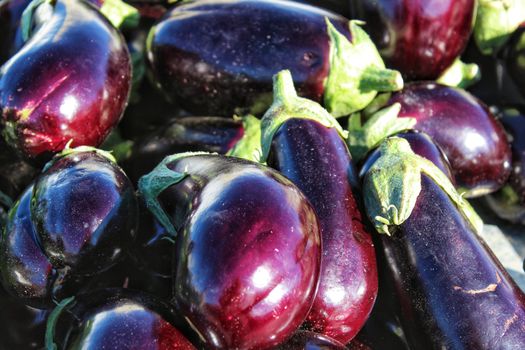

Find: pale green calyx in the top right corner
474;0;525;55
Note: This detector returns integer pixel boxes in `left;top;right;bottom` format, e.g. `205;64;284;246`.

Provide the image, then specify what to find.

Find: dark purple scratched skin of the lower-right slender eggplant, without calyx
364;175;525;350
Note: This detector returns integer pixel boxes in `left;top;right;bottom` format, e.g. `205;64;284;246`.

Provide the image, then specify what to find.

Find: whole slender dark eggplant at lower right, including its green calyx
363;137;525;350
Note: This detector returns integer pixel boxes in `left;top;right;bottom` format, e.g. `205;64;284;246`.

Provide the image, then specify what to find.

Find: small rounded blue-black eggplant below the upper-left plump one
31;150;138;275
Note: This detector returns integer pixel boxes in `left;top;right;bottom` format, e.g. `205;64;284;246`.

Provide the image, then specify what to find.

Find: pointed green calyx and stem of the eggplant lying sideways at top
324;19;403;118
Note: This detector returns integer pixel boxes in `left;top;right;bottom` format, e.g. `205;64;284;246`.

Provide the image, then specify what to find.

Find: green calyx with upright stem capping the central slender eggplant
261;70;347;162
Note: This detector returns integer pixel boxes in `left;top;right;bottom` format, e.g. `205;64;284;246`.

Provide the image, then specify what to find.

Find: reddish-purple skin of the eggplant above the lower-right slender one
389;82;511;197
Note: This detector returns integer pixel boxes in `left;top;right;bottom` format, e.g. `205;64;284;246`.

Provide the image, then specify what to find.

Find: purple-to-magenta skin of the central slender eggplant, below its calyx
267;118;377;343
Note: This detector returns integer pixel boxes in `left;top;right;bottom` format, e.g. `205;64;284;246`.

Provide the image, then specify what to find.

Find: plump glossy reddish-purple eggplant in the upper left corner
0;0;131;162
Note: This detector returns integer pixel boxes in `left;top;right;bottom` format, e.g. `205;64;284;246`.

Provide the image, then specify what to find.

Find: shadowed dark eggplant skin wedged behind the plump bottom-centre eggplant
123;116;244;183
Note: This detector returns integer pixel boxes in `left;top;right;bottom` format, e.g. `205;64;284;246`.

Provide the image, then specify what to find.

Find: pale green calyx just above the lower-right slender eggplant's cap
348;103;417;162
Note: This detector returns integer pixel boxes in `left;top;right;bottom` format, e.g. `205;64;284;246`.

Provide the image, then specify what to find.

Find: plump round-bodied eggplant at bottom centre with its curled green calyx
139;153;321;349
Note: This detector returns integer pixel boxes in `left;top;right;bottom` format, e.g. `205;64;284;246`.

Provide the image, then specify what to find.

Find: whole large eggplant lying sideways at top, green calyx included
147;0;403;117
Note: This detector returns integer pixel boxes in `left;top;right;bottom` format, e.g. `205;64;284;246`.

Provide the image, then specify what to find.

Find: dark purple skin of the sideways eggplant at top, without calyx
148;0;351;117
